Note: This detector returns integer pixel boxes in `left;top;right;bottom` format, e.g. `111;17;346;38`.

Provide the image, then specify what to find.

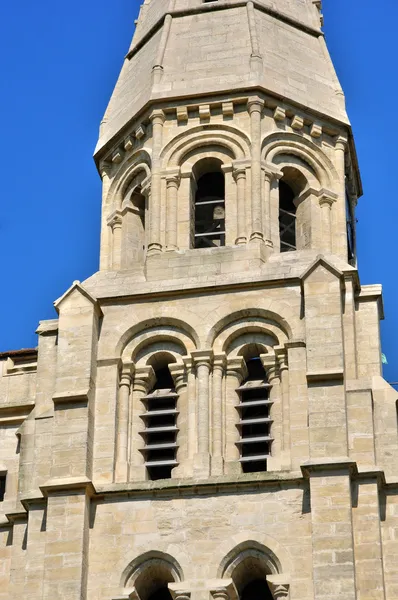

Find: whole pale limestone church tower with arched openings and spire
0;0;398;600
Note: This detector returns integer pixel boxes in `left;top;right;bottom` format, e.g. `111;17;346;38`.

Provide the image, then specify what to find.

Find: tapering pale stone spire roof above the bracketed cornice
96;0;348;157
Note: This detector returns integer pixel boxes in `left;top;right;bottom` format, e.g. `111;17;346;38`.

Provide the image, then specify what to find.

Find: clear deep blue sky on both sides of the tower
0;0;398;381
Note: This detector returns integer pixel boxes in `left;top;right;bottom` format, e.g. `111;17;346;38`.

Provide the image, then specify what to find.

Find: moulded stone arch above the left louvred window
116;317;199;361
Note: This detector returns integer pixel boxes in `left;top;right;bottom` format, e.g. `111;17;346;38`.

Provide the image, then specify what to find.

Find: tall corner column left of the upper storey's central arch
148;110;165;256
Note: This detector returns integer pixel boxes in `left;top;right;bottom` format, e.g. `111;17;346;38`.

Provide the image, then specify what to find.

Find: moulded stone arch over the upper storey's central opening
161;124;250;168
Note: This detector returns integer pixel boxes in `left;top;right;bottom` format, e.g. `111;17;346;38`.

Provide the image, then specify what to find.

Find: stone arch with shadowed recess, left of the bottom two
120;550;184;600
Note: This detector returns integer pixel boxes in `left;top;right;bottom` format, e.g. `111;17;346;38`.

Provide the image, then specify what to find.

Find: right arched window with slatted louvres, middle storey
237;356;272;473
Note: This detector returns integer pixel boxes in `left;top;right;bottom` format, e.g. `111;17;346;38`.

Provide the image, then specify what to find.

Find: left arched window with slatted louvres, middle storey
141;363;178;480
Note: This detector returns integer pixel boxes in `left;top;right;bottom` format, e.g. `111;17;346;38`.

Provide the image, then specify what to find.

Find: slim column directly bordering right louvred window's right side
260;354;282;471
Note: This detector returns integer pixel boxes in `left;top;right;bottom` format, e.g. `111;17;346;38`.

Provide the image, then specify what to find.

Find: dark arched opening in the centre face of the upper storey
195;171;225;248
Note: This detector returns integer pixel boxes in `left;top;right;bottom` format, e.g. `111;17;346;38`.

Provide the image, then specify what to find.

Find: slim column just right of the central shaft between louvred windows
211;354;226;475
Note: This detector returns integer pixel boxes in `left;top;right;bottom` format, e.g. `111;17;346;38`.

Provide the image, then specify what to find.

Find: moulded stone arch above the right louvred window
206;310;292;352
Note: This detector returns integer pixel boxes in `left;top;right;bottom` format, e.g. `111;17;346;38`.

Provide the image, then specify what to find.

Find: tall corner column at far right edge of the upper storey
332;136;348;260
